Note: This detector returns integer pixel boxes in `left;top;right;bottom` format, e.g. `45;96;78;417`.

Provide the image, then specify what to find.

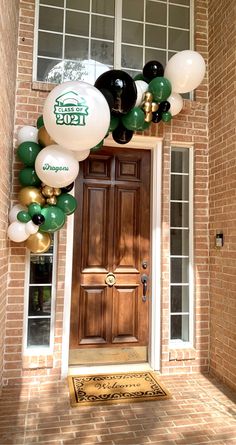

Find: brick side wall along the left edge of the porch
0;0;19;388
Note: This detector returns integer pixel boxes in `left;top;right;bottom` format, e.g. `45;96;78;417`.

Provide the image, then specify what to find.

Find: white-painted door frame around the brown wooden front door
61;135;163;378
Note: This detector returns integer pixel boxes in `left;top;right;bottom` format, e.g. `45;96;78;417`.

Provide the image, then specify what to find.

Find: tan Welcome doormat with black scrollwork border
68;372;171;406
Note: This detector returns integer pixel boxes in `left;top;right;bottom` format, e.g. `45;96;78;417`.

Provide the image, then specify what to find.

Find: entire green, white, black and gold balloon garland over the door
7;50;205;253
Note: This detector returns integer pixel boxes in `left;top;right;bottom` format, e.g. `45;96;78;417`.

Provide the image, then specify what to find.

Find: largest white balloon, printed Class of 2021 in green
43;81;110;151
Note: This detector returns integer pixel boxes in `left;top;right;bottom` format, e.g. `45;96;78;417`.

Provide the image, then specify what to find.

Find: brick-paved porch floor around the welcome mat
0;374;236;445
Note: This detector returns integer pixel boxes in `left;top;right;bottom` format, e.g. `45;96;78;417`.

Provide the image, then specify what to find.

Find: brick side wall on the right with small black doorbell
209;0;236;387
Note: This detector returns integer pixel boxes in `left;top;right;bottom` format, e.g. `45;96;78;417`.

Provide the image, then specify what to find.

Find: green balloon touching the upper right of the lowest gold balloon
40;206;66;232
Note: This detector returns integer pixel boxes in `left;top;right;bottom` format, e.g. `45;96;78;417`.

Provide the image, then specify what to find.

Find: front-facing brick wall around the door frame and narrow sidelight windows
1;0;209;384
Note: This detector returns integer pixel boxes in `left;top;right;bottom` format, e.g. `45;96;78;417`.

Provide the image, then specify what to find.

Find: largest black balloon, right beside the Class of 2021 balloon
95;70;137;115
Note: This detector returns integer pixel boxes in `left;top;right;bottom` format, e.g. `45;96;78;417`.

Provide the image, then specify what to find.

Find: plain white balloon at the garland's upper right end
164;50;206;93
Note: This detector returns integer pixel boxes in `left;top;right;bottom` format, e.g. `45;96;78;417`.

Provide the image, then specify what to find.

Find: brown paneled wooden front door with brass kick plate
70;147;151;364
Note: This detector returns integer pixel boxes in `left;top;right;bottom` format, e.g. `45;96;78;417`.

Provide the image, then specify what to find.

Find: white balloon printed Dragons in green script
35;145;79;188
